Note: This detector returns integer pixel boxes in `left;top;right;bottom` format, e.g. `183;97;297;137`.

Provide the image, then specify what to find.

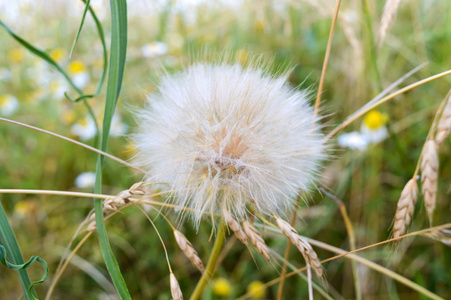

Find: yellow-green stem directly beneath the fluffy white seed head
190;220;227;300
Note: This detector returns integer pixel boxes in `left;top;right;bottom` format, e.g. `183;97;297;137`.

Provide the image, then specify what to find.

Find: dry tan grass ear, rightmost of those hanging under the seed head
276;218;323;277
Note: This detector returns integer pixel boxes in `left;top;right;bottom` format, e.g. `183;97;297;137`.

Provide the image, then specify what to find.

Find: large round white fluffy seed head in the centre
134;63;325;224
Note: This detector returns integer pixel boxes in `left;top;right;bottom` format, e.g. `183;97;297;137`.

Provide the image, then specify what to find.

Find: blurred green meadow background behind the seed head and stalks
0;0;451;299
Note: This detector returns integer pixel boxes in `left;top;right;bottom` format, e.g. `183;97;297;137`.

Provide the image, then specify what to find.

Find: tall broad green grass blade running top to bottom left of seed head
94;0;131;299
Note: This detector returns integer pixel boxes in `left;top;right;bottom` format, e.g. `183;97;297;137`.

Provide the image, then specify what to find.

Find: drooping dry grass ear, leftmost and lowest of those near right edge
393;178;418;238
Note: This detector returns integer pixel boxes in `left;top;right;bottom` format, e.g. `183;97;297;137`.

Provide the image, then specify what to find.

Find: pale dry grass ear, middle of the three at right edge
421;140;439;224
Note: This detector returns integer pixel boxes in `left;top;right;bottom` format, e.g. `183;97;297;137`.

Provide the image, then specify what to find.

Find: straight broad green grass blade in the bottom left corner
0;202;36;300
